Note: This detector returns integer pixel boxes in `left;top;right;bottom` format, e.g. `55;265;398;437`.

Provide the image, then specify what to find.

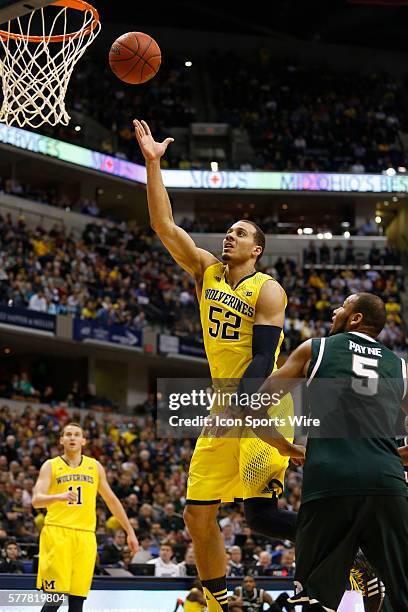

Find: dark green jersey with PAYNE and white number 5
302;332;407;503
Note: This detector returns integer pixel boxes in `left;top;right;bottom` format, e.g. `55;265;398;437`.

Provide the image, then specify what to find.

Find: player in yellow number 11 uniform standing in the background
32;423;138;612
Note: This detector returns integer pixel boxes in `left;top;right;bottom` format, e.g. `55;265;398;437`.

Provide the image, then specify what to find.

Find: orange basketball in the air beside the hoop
109;32;161;85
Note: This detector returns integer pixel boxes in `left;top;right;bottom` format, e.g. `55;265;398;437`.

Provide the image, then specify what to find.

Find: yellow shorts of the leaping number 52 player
187;395;293;504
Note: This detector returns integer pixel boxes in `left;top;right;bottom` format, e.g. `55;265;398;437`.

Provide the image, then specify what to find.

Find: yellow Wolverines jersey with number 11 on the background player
44;455;99;531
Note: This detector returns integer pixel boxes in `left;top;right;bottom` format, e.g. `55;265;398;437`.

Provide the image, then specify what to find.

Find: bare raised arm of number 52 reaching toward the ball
133;119;218;282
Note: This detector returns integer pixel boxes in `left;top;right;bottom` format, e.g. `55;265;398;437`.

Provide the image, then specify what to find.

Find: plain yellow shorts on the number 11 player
37;525;96;597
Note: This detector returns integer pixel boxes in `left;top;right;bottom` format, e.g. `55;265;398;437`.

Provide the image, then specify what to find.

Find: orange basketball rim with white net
0;0;101;128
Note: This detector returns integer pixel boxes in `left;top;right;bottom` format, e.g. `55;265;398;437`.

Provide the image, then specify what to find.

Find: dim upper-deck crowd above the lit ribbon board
29;48;407;173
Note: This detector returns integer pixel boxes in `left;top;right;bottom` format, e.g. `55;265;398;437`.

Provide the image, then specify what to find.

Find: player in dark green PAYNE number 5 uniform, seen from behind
257;293;408;612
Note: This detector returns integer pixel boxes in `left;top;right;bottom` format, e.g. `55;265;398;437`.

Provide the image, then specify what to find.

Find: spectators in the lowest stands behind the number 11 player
0;405;301;576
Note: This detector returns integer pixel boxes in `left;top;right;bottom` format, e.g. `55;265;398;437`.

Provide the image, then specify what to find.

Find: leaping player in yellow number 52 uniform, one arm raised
134;120;304;612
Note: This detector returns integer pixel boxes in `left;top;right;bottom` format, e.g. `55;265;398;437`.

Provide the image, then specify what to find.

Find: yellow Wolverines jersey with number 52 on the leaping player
200;262;284;380
